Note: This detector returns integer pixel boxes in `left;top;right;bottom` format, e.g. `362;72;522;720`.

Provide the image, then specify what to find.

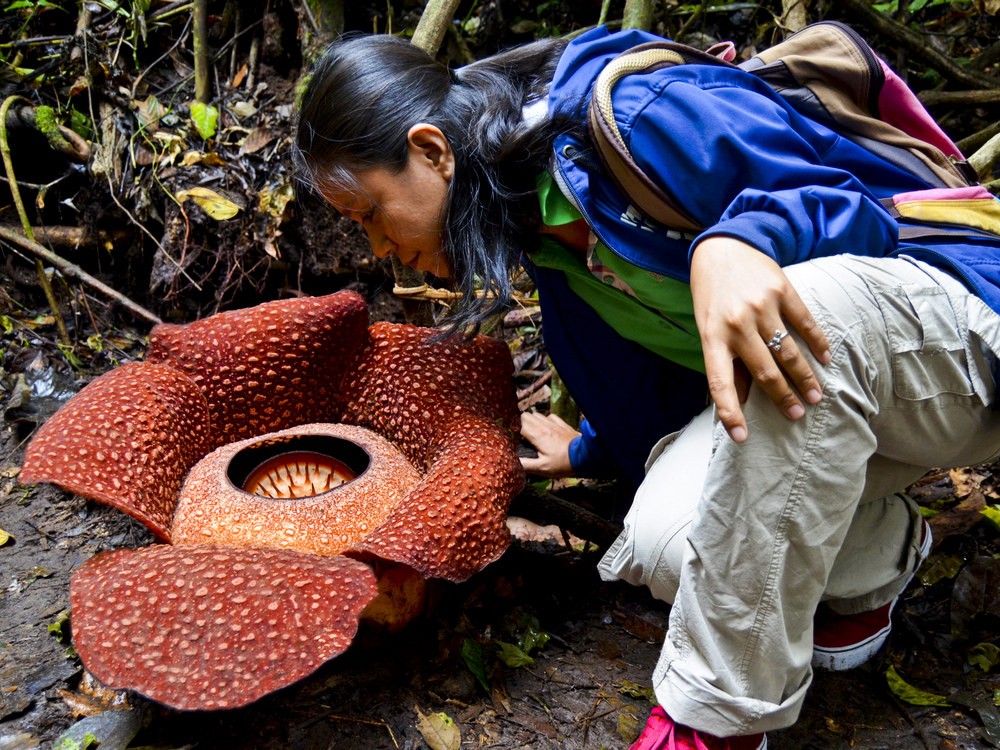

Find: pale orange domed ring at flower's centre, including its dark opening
170;424;420;555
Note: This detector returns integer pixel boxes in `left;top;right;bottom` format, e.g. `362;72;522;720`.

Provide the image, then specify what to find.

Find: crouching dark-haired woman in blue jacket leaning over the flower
297;29;1000;750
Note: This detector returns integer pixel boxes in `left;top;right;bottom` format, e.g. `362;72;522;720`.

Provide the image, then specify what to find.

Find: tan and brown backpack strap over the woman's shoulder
587;40;728;232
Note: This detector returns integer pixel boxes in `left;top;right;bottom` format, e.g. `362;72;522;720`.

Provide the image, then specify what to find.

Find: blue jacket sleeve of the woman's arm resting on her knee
615;65;897;265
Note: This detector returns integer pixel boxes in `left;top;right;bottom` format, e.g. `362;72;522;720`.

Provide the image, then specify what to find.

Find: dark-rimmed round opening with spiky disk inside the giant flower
228;435;371;499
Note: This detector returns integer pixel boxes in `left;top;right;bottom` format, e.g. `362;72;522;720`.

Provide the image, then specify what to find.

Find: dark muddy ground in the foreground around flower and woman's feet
0;358;1000;750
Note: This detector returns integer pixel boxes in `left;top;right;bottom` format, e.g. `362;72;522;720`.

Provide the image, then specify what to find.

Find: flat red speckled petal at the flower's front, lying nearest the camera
70;545;376;710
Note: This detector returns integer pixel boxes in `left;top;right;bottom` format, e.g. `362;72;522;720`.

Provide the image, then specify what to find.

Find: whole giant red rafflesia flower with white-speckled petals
21;292;524;709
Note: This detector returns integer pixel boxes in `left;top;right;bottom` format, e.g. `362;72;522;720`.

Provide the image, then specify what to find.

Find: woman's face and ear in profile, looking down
323;124;454;278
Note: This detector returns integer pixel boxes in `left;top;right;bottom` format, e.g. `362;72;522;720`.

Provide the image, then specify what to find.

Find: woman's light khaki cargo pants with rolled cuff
599;256;1000;736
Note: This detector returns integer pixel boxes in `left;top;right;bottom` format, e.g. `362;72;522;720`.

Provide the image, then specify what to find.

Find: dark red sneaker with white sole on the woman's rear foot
812;521;932;672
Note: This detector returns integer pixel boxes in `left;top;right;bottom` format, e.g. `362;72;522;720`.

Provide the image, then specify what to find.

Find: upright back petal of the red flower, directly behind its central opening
146;291;368;447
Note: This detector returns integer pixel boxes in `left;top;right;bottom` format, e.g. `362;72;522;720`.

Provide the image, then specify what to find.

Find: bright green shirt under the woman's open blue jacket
531;173;705;372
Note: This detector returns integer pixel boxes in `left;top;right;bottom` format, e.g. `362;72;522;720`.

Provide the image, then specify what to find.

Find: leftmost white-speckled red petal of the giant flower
20;363;209;539
